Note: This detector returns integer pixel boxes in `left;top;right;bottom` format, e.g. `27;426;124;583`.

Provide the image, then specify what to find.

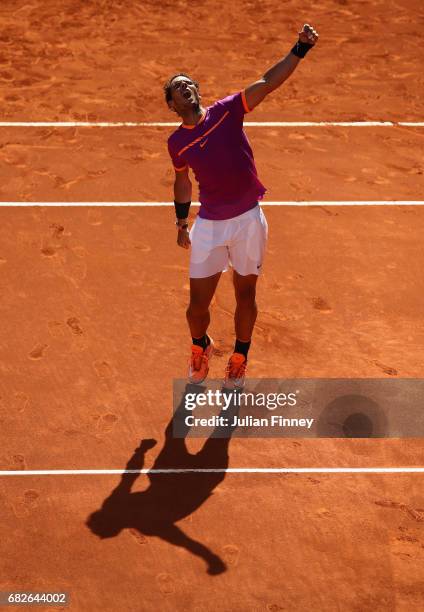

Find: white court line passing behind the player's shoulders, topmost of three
0;121;424;127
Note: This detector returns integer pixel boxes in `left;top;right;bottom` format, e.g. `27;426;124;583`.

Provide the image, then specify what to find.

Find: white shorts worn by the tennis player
190;205;268;278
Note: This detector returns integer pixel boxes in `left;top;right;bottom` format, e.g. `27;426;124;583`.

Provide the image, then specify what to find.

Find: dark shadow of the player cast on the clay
87;385;238;575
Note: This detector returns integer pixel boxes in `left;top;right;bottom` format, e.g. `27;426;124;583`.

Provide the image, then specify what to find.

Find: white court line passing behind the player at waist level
0;200;424;208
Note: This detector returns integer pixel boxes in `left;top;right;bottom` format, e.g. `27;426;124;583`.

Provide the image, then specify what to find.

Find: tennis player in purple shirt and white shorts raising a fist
164;24;318;389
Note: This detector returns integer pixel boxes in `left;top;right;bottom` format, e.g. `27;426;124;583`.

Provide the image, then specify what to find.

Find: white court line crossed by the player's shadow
0;467;424;476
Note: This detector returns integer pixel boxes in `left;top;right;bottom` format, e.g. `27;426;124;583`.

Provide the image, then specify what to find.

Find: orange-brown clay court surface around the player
0;0;424;612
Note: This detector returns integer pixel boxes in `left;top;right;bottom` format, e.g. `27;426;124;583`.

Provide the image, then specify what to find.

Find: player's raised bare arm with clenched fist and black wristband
245;24;318;110
